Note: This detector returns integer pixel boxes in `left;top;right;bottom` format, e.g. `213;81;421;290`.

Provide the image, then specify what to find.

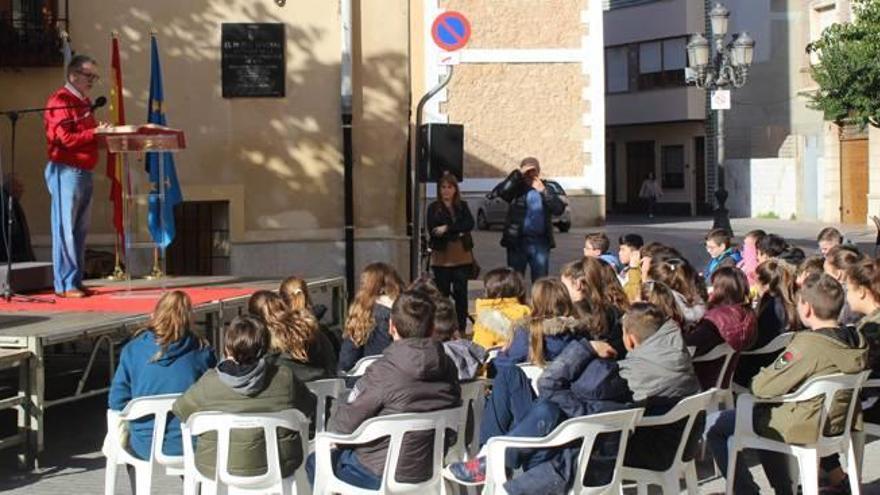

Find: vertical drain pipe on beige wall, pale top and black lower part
339;0;355;302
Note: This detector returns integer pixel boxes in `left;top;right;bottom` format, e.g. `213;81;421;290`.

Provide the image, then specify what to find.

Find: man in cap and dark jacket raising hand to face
492;157;565;282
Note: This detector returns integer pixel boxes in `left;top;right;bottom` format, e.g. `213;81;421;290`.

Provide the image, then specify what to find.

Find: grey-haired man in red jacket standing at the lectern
43;55;105;298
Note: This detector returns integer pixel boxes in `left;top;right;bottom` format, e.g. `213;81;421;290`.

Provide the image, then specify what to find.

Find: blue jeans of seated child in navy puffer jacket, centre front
480;364;535;446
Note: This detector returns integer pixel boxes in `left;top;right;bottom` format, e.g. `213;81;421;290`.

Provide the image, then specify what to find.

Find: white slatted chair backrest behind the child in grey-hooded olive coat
181;409;309;489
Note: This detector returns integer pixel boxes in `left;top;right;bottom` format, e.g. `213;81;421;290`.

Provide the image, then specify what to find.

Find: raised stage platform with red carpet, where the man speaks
0;276;347;467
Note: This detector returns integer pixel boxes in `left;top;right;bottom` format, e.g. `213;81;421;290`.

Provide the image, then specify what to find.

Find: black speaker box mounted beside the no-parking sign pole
419;124;464;182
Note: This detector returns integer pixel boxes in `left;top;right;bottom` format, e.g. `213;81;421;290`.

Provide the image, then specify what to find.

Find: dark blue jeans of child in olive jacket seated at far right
706;410;792;495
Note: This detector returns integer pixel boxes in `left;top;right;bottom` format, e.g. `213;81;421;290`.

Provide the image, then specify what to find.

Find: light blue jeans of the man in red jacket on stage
45;162;92;293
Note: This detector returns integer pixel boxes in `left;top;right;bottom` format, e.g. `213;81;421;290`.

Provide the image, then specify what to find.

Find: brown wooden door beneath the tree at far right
840;139;868;224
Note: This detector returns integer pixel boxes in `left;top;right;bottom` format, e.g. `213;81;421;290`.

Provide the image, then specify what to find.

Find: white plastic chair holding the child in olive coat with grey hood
181;409;309;495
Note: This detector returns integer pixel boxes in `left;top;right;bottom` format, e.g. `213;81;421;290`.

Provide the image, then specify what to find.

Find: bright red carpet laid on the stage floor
0;287;256;314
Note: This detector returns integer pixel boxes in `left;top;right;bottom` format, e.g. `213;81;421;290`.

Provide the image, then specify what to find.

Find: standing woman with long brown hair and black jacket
426;172;474;330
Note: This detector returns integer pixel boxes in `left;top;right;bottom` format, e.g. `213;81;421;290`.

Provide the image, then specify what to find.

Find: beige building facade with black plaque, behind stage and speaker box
0;0;605;277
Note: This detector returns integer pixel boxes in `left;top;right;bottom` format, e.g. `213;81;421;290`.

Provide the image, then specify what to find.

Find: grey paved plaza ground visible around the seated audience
0;216;880;495
